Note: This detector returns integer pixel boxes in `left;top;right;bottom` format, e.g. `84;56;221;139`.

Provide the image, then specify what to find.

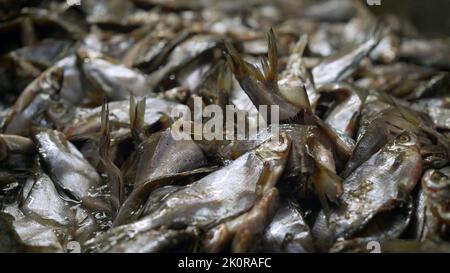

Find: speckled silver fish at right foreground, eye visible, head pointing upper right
313;131;422;250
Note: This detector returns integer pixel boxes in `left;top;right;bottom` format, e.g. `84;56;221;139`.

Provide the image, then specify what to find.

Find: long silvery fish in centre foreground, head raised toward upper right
86;136;290;249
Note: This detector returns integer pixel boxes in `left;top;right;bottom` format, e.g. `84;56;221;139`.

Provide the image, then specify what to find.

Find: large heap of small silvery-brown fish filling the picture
0;0;450;253
